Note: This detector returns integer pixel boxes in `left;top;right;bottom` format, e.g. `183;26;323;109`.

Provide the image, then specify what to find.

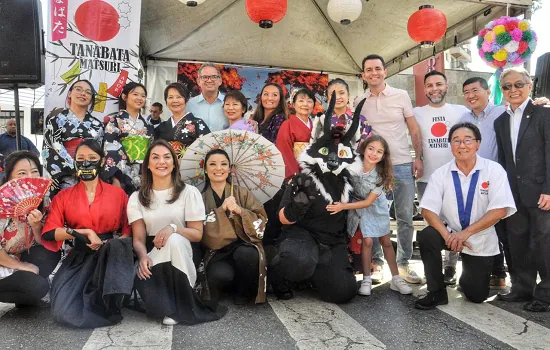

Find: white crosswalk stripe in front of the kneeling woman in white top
82;309;173;350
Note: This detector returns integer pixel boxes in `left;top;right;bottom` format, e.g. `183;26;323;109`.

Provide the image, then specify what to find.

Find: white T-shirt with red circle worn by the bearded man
413;103;468;182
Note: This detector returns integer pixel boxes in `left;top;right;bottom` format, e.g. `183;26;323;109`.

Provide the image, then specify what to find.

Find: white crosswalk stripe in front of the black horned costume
269;296;386;350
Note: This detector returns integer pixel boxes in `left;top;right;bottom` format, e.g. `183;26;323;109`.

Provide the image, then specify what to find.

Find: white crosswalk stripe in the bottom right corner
438;288;550;350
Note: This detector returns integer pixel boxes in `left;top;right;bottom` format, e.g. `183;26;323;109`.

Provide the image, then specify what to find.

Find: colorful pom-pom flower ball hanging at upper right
477;16;537;69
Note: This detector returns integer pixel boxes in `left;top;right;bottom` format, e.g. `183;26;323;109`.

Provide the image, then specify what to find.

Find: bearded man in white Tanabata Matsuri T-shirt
413;71;468;285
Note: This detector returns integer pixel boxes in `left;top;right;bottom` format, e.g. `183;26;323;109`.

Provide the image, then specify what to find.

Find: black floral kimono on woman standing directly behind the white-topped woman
155;113;210;159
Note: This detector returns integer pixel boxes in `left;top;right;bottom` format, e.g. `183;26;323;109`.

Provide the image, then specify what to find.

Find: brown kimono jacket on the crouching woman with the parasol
197;184;267;303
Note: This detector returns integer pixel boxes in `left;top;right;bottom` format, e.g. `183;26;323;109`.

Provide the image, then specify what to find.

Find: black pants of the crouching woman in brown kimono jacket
206;244;260;303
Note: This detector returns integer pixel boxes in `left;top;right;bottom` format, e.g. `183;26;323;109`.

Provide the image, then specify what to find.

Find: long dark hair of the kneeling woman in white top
138;139;185;209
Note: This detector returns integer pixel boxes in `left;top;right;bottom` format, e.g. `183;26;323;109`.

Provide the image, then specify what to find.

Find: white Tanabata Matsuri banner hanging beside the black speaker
44;0;143;120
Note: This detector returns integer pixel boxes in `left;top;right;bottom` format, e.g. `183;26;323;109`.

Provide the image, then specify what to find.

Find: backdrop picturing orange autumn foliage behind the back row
178;62;328;114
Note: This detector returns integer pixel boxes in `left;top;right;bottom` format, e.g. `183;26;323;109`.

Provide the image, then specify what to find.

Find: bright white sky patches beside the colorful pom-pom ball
468;0;550;75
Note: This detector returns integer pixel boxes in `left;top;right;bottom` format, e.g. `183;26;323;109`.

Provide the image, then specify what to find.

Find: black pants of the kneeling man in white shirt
416;226;494;303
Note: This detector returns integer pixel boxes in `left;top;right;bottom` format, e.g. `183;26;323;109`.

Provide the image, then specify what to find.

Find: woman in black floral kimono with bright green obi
103;82;154;195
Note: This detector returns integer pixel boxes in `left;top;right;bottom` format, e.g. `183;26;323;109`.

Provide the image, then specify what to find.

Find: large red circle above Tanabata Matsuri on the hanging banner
74;0;120;41
